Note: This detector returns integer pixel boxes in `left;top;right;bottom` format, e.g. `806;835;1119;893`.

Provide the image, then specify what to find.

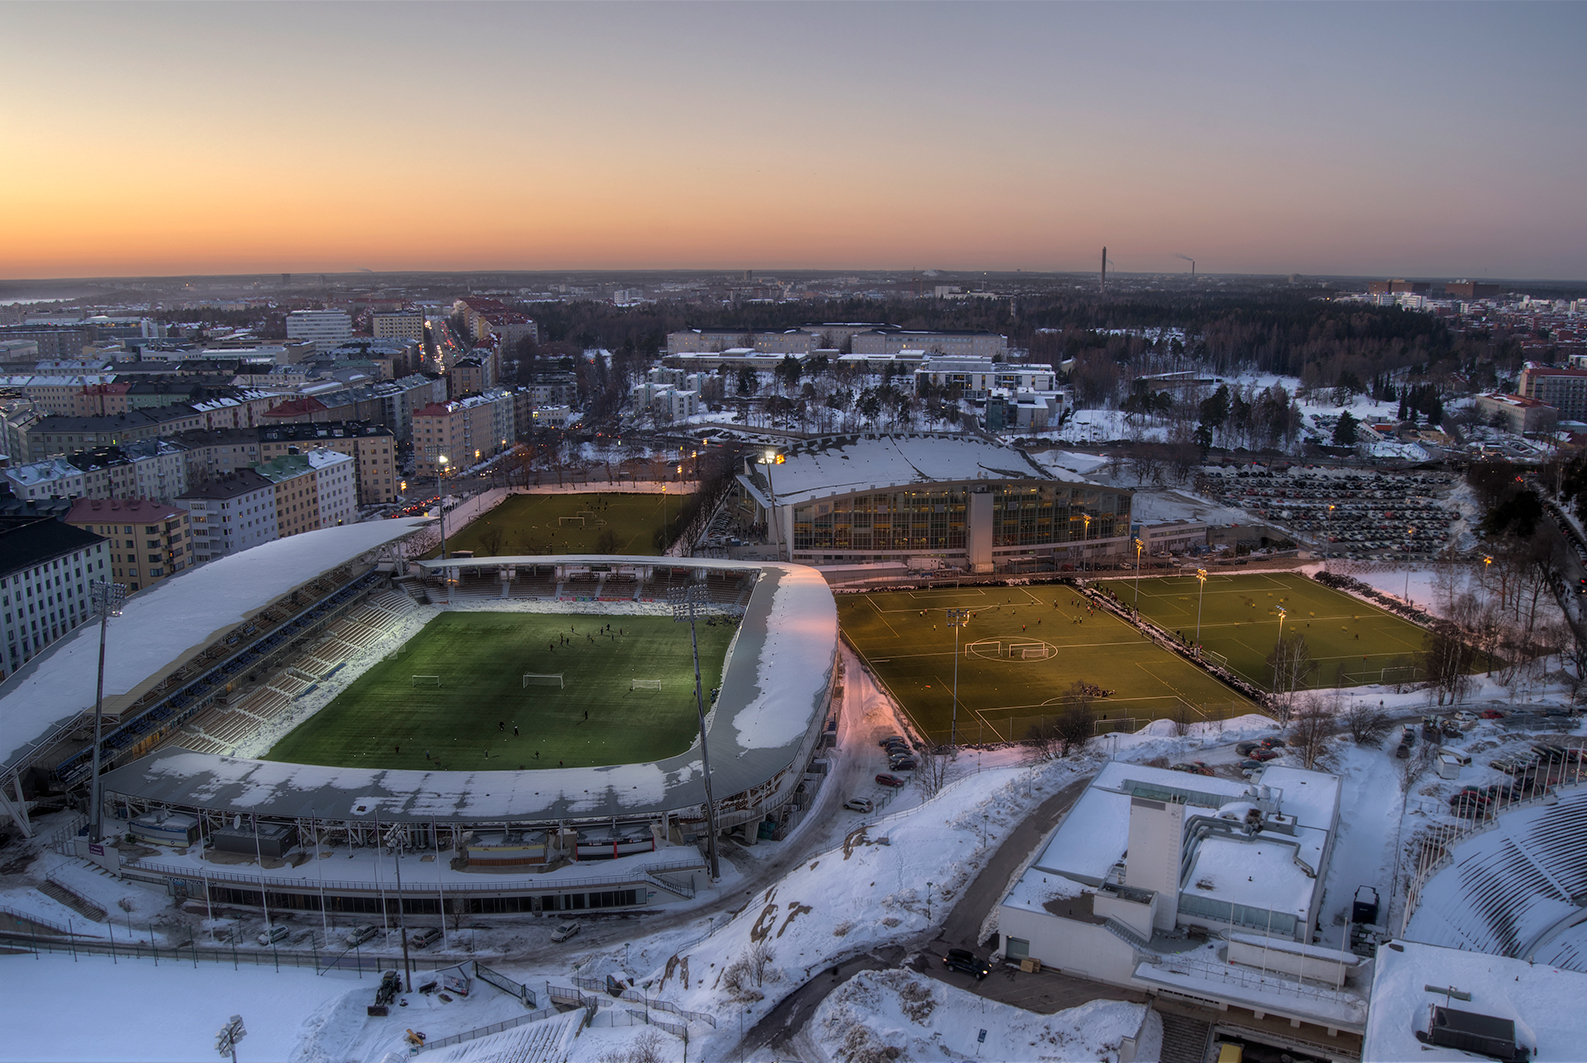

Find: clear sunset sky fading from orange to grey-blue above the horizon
0;3;1587;279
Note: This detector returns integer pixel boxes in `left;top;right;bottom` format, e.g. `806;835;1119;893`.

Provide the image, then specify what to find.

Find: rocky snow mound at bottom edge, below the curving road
808;971;1162;1063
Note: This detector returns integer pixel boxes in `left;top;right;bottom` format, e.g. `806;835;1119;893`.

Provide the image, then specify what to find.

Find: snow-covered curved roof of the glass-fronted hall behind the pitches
741;435;1054;506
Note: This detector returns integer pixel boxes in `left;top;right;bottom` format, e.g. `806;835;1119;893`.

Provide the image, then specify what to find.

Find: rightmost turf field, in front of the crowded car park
1108;573;1424;689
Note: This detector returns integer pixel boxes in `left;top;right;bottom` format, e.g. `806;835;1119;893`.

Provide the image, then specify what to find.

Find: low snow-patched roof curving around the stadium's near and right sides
96;554;838;822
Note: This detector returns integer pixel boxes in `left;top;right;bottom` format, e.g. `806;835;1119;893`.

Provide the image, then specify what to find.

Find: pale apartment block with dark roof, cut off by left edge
0;517;110;676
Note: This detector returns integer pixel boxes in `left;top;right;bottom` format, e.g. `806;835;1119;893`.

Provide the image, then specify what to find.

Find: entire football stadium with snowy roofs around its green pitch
0;519;840;914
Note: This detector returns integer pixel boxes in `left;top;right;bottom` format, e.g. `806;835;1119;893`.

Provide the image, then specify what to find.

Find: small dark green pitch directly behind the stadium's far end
436;493;684;557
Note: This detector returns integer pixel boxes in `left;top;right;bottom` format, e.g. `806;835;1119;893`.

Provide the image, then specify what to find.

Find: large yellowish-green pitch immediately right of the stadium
838;584;1255;743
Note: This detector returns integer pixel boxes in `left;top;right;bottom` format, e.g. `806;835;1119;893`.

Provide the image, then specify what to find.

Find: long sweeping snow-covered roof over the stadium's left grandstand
0;517;427;765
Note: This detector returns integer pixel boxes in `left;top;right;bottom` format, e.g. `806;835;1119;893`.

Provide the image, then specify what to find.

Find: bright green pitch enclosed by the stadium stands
265;612;735;771
